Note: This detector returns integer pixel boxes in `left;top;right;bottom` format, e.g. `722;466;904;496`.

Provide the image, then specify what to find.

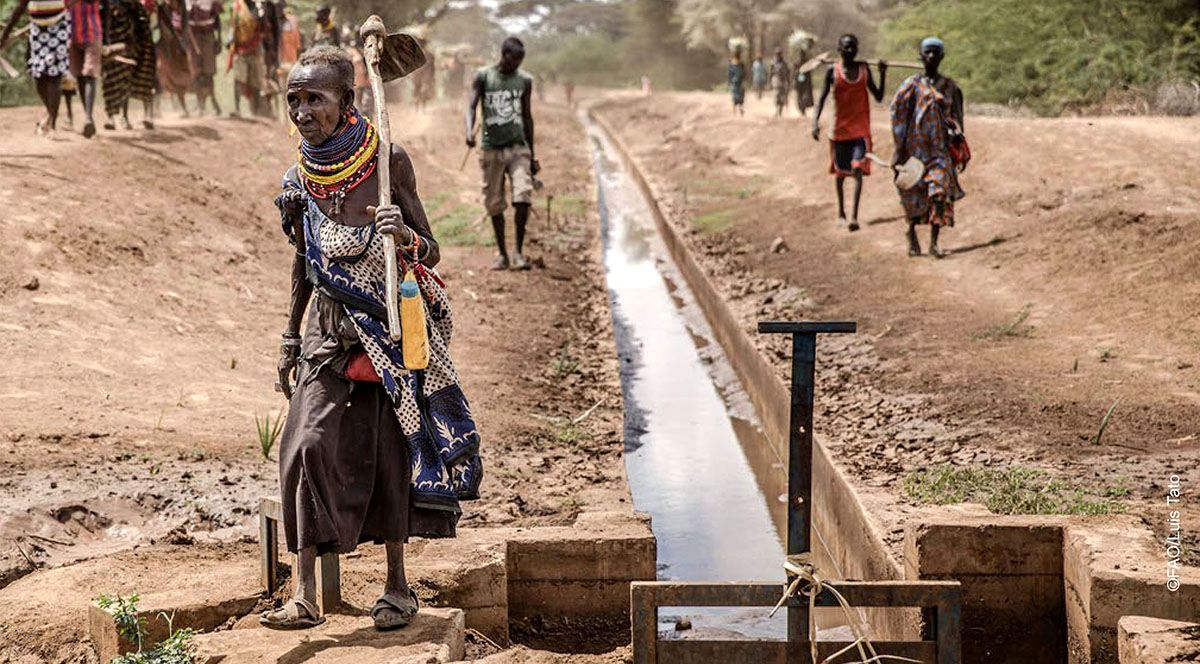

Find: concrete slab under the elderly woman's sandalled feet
194;609;464;664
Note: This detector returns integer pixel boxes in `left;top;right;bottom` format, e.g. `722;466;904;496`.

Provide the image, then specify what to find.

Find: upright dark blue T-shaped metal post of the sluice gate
758;322;858;659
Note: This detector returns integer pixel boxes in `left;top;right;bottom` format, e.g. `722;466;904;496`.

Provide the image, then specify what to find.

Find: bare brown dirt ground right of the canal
599;92;1200;564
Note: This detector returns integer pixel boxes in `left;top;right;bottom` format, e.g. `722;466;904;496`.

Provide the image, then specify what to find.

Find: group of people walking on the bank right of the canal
727;35;971;258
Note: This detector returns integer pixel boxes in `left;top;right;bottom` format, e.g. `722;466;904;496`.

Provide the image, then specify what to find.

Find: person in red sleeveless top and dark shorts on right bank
812;35;888;231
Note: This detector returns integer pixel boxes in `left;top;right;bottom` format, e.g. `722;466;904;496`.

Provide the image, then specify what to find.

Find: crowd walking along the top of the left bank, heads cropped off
0;0;336;138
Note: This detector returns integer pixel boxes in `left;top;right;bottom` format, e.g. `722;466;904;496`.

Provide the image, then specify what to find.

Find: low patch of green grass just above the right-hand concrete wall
901;465;1124;514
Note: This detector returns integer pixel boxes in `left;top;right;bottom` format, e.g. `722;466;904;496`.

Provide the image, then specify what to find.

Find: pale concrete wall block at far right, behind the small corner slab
1063;516;1200;664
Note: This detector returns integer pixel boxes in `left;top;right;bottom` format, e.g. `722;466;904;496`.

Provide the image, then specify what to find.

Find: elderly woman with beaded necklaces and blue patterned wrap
267;46;482;629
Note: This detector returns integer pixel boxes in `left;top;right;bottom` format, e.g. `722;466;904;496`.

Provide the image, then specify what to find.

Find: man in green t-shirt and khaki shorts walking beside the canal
467;37;538;270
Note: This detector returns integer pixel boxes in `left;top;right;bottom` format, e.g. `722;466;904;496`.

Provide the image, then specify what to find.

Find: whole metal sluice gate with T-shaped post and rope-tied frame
630;322;962;664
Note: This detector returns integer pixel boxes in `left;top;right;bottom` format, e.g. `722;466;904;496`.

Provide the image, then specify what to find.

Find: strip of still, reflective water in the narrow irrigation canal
586;115;786;638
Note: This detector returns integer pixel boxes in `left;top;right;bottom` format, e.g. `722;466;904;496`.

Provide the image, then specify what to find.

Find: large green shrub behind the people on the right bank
881;0;1200;114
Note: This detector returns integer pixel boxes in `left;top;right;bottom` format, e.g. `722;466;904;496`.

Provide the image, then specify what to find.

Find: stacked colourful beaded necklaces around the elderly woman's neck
299;109;379;216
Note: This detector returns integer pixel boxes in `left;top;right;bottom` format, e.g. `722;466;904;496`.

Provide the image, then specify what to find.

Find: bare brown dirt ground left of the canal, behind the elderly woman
0;100;629;662
